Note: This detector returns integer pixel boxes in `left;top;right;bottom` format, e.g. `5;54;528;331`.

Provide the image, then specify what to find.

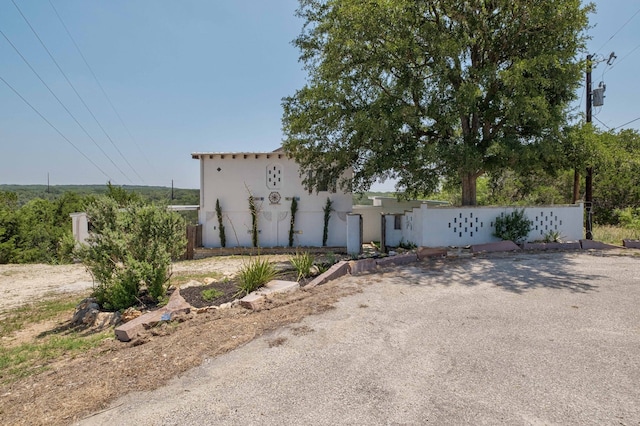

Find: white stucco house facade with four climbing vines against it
191;150;352;248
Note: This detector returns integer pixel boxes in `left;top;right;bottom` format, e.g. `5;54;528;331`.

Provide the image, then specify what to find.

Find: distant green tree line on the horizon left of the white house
0;183;199;264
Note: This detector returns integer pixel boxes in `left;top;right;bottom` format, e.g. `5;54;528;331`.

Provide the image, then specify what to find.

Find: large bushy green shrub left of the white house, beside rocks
76;197;186;310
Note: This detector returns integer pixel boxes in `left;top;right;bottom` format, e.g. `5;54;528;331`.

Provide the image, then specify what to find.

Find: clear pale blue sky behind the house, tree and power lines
0;0;640;189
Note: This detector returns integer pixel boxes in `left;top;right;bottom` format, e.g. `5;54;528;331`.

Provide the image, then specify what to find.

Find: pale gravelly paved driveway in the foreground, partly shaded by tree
80;253;640;425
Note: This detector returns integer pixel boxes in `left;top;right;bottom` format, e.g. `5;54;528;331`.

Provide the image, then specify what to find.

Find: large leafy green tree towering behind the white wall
283;0;592;205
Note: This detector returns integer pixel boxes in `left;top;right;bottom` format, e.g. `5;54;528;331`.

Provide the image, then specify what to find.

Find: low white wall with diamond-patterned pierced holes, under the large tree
383;203;583;247
